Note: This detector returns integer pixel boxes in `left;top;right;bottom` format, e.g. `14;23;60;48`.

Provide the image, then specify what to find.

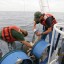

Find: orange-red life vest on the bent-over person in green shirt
2;26;19;42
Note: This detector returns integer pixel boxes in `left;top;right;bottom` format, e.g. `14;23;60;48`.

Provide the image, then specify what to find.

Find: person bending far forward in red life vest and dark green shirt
0;26;32;51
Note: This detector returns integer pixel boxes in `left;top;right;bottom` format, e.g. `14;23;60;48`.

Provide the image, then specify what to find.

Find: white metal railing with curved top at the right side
48;23;64;64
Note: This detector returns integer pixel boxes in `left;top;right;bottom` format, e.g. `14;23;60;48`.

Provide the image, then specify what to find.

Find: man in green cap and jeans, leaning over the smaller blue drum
33;11;57;56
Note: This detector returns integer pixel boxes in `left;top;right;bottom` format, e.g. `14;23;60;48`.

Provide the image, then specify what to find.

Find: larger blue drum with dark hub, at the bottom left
0;50;32;64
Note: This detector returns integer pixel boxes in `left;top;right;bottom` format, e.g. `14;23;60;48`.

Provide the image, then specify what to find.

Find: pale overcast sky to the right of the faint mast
49;0;64;12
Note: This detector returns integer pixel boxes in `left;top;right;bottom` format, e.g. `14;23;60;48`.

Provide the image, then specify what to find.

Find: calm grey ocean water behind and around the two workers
0;11;64;54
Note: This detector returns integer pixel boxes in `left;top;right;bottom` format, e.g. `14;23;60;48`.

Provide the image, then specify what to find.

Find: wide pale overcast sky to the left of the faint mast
0;0;40;11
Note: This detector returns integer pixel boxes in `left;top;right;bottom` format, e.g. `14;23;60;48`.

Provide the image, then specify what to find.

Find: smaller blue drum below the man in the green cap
31;40;49;58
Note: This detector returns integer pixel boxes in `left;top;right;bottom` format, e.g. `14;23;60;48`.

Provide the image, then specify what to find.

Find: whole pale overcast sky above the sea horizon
0;0;64;12
